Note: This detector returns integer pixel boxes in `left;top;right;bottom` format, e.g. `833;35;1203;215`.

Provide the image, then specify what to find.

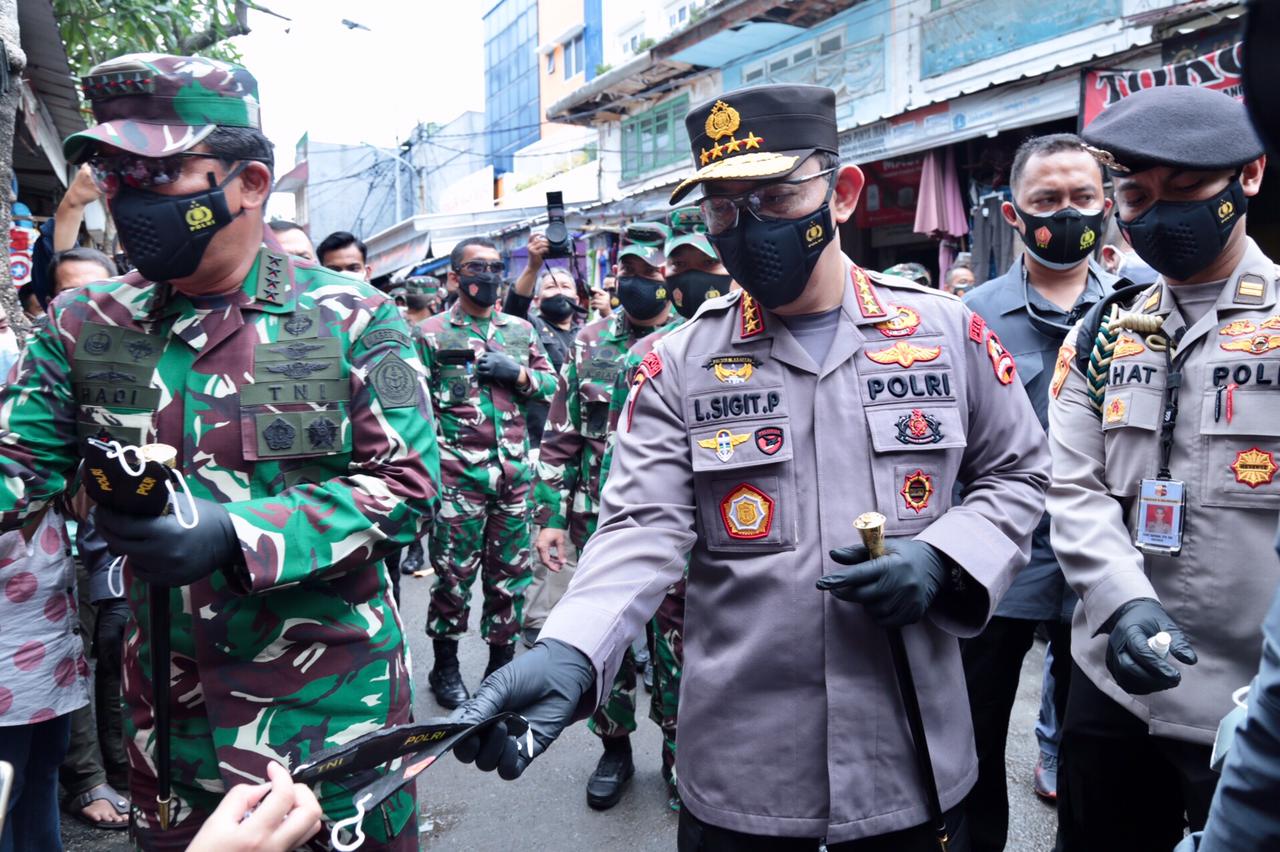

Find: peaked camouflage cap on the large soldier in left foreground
63;54;262;162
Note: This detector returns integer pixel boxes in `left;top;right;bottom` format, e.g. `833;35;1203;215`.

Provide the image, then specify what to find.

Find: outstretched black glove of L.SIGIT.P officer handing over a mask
449;640;595;780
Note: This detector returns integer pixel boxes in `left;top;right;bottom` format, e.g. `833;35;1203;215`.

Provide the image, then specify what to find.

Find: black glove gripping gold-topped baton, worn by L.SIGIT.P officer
818;539;947;627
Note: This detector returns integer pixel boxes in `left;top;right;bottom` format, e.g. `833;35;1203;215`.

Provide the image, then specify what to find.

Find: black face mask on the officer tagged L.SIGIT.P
708;195;835;308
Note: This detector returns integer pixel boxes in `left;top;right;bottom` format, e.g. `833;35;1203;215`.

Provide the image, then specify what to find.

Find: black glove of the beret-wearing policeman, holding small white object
1102;597;1198;695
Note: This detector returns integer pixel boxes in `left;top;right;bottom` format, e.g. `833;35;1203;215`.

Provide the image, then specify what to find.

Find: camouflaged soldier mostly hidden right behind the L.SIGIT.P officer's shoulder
600;207;737;811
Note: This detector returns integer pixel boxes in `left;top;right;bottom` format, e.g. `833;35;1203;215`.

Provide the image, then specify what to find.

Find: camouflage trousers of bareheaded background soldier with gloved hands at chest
426;475;534;646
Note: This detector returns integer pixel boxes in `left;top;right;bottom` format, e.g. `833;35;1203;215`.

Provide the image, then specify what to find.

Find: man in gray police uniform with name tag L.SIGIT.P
460;86;1048;852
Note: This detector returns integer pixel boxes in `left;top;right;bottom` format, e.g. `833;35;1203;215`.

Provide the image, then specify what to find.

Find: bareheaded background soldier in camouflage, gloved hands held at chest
419;238;556;710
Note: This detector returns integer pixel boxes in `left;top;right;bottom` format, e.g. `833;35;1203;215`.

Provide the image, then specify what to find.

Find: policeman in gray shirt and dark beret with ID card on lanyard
1048;86;1280;852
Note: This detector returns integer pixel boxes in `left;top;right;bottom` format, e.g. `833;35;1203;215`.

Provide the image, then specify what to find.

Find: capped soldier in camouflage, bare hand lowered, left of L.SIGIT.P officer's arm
534;223;671;810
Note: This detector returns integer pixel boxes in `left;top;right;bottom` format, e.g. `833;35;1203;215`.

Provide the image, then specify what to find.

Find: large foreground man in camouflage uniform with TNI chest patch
0;54;438;849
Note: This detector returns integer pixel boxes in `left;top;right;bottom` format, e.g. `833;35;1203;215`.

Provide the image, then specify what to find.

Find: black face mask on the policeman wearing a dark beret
1120;175;1249;281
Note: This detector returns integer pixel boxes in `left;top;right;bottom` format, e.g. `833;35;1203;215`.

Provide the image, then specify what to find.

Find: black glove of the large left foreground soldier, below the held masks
95;499;243;588
